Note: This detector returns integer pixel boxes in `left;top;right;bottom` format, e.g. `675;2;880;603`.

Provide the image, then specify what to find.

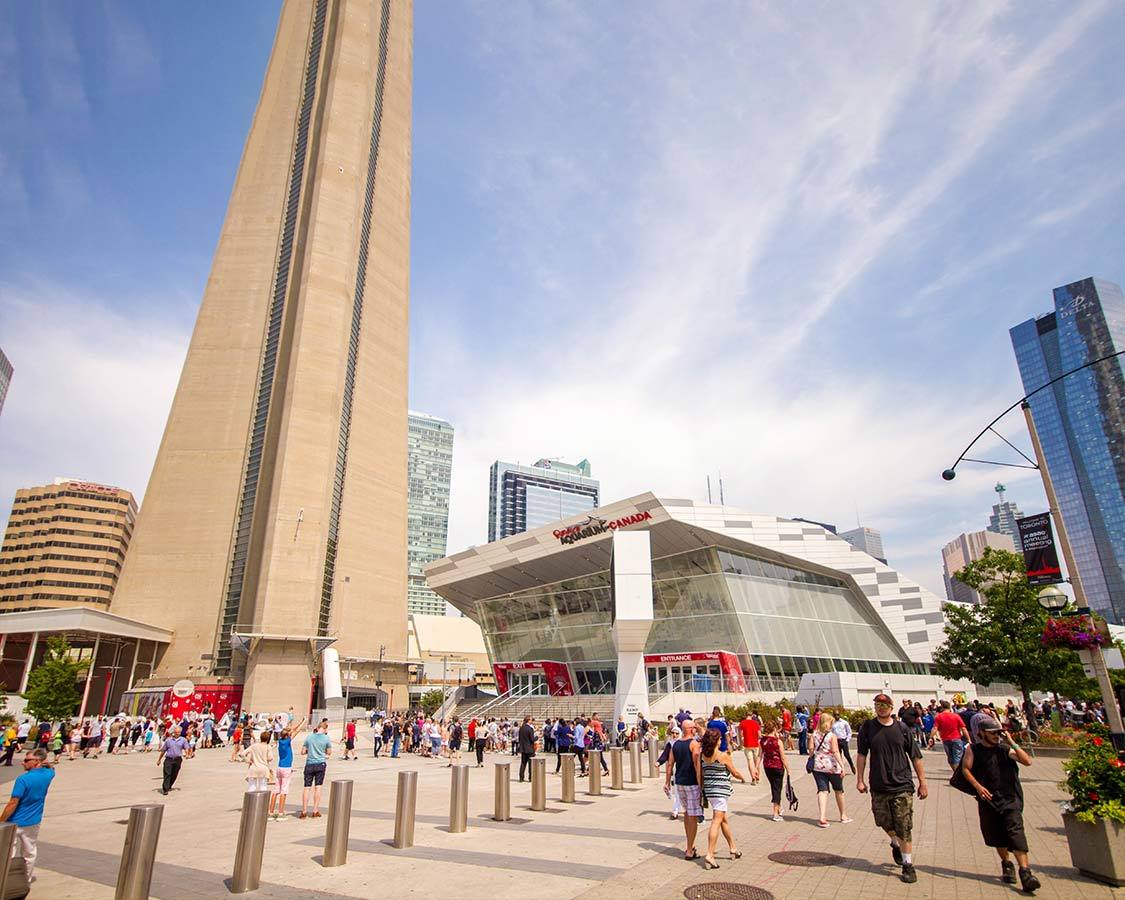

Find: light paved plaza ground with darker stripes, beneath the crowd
21;749;1125;900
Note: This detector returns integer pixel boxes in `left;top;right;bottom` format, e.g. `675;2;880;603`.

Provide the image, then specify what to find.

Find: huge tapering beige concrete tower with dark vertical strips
114;0;413;710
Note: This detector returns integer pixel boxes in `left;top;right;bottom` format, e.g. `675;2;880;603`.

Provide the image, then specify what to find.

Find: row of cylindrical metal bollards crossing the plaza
101;741;659;900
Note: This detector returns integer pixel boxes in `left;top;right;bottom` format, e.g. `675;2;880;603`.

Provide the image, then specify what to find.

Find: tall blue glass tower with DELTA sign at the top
1010;278;1125;624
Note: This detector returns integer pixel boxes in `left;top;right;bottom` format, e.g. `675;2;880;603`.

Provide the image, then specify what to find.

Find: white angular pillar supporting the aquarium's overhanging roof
611;530;653;722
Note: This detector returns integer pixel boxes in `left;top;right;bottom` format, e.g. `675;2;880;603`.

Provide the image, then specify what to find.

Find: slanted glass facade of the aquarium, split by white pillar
474;547;926;693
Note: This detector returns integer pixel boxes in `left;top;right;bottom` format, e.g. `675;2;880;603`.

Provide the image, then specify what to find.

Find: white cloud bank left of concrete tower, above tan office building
0;280;190;509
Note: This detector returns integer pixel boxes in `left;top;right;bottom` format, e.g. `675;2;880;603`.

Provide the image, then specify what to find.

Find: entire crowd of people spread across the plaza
0;694;1105;893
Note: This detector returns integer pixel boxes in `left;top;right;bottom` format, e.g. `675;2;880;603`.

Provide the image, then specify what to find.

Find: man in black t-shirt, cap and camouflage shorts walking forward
855;694;929;884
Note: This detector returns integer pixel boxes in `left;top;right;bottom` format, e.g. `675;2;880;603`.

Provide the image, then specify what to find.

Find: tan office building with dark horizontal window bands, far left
0;478;137;612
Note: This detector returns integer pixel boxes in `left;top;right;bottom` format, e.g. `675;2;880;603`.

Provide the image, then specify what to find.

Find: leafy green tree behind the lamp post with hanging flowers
934;547;1086;700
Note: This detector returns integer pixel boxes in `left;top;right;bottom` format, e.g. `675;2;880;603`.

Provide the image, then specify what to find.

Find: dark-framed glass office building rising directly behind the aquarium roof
488;459;599;541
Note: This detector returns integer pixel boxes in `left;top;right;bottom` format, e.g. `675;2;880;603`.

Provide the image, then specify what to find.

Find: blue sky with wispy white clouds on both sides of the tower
0;0;1125;594
